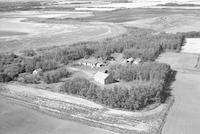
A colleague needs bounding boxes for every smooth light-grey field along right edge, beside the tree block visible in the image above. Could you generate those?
[158,53,200,134]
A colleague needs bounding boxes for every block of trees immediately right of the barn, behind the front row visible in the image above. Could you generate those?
[109,62,171,81]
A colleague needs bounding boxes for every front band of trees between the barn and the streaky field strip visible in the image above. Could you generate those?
[61,78,168,110]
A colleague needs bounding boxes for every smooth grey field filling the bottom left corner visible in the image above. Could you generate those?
[0,97,114,134]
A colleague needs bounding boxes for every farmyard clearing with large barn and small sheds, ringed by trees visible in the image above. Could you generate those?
[76,54,142,85]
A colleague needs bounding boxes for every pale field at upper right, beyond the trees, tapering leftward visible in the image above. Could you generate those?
[123,11,200,33]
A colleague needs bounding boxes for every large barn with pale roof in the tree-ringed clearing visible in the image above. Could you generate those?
[94,72,114,85]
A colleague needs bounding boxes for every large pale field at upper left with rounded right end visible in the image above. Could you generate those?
[0,11,126,52]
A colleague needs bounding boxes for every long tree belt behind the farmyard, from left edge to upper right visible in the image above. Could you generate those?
[0,28,185,82]
